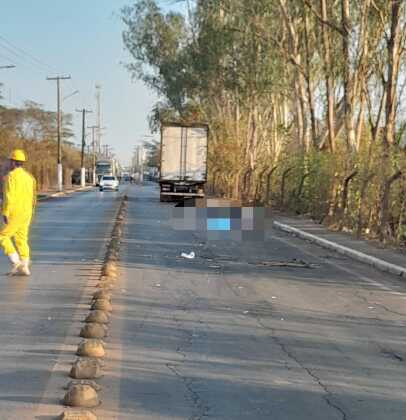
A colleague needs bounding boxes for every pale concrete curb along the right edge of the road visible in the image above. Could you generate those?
[273,222,406,278]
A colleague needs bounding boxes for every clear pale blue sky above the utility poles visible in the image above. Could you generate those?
[0,0,182,164]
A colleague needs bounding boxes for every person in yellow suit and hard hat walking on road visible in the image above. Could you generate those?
[0,149,37,276]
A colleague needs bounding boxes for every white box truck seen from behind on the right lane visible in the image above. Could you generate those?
[159,122,209,201]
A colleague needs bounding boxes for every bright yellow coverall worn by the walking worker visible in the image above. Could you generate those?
[0,168,37,260]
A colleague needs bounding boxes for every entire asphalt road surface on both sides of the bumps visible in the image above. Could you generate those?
[0,186,406,420]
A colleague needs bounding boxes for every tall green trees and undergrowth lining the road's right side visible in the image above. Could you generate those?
[122,0,406,246]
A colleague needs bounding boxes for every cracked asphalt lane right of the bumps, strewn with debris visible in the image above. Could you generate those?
[97,186,406,420]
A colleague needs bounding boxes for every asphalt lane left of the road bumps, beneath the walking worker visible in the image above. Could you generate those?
[0,191,121,420]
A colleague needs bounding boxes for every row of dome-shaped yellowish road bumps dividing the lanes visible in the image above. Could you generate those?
[60,196,128,420]
